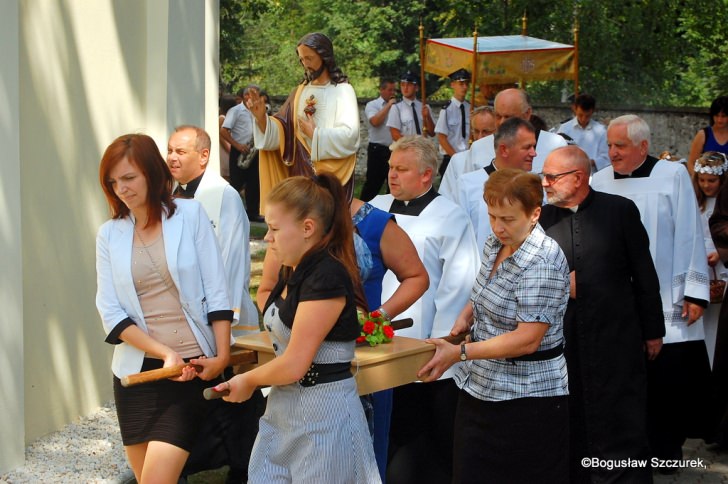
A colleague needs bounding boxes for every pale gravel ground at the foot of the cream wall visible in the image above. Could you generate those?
[0,402,133,484]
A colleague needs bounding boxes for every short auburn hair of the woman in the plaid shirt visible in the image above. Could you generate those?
[483,168,543,214]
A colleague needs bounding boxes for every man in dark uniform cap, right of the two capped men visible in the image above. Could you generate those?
[435,69,470,175]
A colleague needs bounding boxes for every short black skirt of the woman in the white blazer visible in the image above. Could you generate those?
[114,358,217,452]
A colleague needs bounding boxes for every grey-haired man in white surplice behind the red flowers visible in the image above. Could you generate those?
[369,136,480,482]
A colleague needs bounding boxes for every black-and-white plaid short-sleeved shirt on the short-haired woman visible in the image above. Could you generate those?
[454,225,569,401]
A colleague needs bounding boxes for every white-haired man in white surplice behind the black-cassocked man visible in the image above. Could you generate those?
[592,115,710,466]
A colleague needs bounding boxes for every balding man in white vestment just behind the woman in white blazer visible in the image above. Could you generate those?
[167,125,265,482]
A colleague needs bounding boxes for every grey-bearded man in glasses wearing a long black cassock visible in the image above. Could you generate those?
[540,146,665,482]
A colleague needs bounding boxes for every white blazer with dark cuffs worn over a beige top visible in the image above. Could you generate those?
[96,199,232,378]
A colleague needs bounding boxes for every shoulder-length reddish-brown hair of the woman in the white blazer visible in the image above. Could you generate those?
[99,134,177,224]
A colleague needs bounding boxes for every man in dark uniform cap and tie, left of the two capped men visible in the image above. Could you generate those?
[387,71,435,141]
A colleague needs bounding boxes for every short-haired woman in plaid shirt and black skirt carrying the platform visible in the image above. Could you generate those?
[419,169,569,483]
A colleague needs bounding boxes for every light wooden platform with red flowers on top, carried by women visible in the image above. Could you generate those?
[235,332,435,395]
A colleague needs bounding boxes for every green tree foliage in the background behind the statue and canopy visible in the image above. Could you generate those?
[220,0,728,106]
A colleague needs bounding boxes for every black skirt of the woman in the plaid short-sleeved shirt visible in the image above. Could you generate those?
[452,391,569,484]
